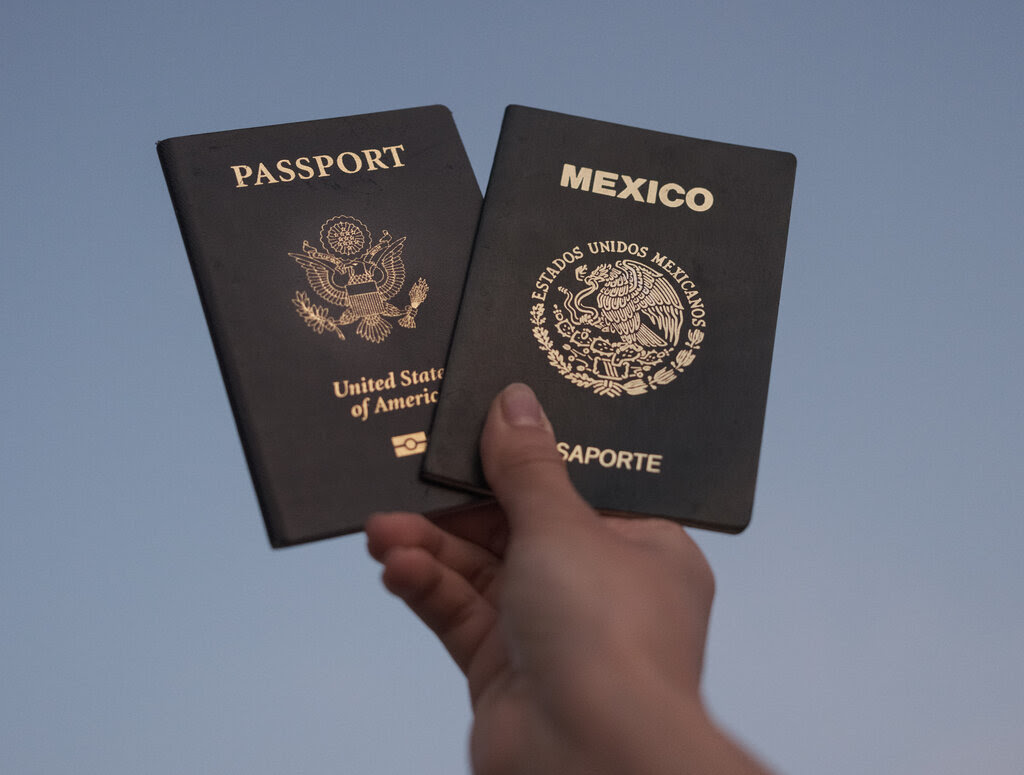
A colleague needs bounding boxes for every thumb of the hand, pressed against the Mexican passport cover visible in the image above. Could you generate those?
[480,383,594,532]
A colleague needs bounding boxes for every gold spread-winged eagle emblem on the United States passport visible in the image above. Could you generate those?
[288,215,430,344]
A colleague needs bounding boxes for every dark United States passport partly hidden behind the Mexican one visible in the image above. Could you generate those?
[157,105,480,547]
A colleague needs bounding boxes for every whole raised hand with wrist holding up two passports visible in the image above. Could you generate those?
[367,385,764,775]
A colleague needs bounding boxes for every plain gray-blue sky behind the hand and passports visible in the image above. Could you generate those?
[0,2,1024,775]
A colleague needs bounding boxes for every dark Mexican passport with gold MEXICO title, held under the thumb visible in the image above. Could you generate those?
[424,105,796,532]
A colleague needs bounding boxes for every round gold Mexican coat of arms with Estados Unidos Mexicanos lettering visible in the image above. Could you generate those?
[529,241,708,397]
